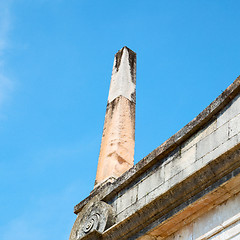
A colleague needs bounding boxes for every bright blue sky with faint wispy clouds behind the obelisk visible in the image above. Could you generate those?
[0,0,240,240]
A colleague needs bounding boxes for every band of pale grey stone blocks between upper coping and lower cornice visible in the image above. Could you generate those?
[111,95,240,223]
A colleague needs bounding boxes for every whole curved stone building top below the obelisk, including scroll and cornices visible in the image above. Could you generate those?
[70,77,240,240]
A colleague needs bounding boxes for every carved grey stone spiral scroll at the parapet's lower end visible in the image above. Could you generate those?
[69,201,115,240]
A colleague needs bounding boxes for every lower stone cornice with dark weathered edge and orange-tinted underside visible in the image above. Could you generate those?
[102,144,240,240]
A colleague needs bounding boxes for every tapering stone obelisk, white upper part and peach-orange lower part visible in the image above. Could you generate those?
[95,47,136,185]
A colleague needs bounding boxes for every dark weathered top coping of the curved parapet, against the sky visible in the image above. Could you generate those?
[74,77,240,214]
